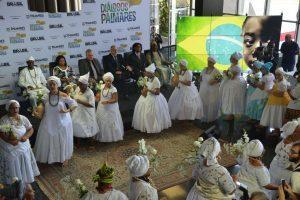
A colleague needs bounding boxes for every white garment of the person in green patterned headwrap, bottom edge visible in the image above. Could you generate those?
[81,189,128,200]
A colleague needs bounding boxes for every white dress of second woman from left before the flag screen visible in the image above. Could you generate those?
[199,68,220,122]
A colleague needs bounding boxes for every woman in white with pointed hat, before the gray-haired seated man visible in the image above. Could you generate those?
[71,73,99,138]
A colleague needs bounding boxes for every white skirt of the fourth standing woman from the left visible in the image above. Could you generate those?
[95,102,124,142]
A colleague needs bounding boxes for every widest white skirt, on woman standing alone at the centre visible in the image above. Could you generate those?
[132,93,172,133]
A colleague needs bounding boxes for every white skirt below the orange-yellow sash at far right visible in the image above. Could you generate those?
[260,104,286,128]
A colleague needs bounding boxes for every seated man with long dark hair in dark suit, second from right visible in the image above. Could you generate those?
[126,43,146,80]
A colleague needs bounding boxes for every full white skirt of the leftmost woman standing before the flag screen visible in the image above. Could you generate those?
[168,84,203,120]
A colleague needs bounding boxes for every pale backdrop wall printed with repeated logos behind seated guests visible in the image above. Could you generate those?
[0,0,150,104]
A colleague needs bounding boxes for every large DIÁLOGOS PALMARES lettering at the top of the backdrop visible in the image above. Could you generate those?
[100,0,141,24]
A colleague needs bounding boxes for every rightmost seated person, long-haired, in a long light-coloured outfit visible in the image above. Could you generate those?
[146,41,172,85]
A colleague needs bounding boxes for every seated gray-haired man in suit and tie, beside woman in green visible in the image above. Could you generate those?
[78,49,104,81]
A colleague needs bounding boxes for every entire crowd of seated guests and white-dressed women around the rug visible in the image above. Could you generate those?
[0,34,300,200]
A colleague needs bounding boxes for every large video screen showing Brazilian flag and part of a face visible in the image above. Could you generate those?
[176,16,282,72]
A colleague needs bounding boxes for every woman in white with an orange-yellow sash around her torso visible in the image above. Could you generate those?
[260,67,291,133]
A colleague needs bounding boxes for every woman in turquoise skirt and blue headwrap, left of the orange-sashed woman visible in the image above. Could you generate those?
[246,62,275,121]
